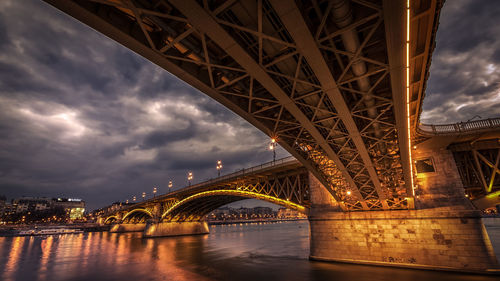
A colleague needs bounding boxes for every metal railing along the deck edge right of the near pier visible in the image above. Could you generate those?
[417,117,500,135]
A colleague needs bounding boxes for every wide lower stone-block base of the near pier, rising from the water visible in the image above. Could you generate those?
[309,208,498,271]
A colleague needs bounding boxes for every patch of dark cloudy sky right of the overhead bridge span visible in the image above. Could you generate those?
[421,0,500,123]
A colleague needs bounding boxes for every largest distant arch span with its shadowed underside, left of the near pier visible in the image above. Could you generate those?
[161,190,307,221]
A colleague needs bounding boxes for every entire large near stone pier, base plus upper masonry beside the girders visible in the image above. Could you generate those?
[309,145,500,273]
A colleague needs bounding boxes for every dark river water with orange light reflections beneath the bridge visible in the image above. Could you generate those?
[0,221,498,281]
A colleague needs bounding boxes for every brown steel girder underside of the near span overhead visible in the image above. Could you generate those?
[46,0,442,210]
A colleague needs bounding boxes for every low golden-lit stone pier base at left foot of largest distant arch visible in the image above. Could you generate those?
[143,222,210,237]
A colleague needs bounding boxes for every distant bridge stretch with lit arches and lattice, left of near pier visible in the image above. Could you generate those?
[103,157,310,224]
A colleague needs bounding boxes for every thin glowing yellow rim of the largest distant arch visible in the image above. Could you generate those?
[161,190,306,220]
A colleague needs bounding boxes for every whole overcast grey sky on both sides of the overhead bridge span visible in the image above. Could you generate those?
[0,0,500,209]
